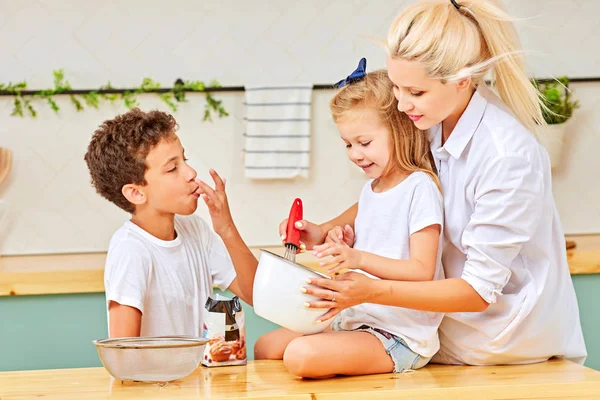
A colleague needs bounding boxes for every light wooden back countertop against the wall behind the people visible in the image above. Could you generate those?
[0,235,600,296]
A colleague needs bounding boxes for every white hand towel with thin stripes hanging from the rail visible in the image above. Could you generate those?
[244,85,312,179]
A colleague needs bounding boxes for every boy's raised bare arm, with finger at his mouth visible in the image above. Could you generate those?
[196,169,258,305]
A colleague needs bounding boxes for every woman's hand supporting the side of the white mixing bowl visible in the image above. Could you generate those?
[300,272,378,322]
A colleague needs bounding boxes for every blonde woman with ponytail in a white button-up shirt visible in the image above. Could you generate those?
[290,0,586,365]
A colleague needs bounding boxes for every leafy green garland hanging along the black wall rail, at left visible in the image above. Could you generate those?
[0,69,229,122]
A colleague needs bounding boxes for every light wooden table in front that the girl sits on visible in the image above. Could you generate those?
[0,360,600,400]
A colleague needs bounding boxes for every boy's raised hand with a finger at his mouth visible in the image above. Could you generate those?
[196,169,235,237]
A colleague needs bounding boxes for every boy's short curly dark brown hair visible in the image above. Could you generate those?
[84,108,177,213]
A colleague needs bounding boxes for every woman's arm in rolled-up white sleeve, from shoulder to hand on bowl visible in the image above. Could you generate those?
[307,154,544,317]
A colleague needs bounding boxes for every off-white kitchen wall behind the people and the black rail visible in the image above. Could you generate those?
[0,0,600,254]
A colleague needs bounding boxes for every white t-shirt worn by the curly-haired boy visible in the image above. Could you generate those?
[104,214,236,336]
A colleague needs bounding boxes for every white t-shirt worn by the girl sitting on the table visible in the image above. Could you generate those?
[341,172,444,357]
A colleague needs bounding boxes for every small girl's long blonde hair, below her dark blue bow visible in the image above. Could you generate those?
[329,70,441,191]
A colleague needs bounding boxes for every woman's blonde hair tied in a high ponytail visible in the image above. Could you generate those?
[387,0,545,133]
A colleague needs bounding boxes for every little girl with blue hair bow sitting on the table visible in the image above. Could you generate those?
[257,59,443,378]
